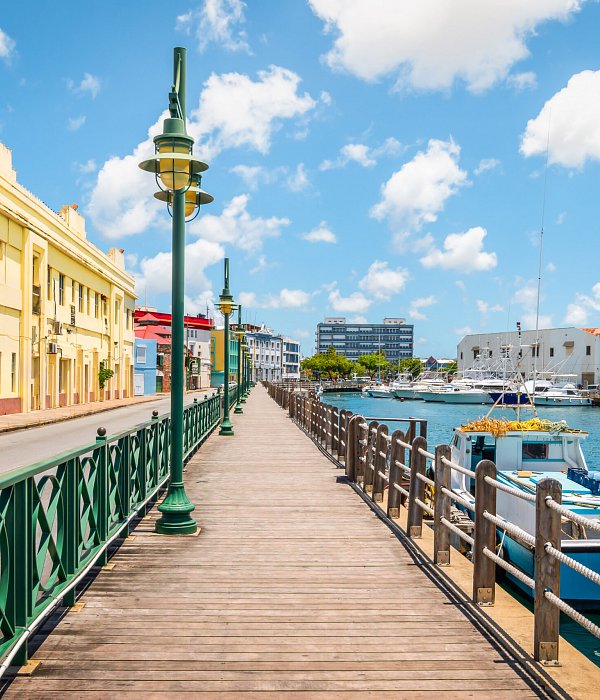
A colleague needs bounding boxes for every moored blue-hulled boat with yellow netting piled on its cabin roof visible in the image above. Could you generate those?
[451,418,600,608]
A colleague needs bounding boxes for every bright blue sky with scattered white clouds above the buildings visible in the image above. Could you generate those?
[0,0,600,356]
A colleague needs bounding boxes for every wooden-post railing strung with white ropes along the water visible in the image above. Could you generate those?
[267,383,600,664]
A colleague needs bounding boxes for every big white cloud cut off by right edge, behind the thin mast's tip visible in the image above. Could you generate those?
[521,70,600,168]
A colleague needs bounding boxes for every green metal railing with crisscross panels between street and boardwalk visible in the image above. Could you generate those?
[0,396,223,675]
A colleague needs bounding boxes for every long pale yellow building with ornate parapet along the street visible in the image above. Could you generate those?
[0,143,135,414]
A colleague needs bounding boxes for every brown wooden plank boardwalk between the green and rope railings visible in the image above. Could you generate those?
[6,387,554,700]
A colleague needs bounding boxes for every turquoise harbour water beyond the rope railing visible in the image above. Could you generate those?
[322,393,600,666]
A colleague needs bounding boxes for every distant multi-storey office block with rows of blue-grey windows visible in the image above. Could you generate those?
[316,316,414,362]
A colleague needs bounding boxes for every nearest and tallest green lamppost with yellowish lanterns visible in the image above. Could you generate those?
[139,47,213,535]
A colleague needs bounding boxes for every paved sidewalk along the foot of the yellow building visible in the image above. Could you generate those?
[0,388,214,433]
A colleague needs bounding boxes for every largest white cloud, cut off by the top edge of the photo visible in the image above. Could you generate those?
[309,0,584,92]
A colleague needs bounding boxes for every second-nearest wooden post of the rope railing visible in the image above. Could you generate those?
[473,459,496,605]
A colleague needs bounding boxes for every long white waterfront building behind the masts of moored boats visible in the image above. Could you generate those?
[457,327,600,387]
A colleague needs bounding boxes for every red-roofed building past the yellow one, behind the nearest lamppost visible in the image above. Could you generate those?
[135,306,213,392]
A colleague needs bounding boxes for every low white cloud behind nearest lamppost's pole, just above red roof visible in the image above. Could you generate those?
[133,239,225,299]
